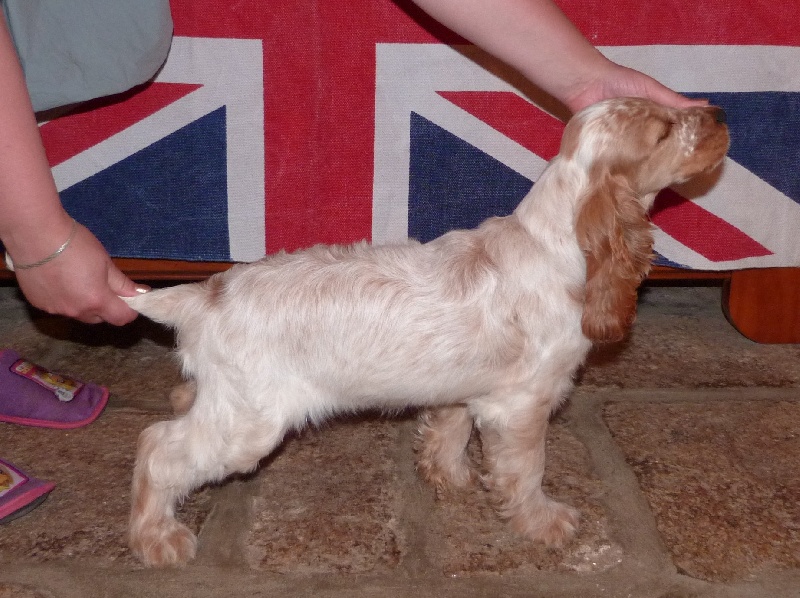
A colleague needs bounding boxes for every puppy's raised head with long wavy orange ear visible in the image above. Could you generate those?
[560,98,730,341]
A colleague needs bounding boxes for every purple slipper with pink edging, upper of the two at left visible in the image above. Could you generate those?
[0,349,108,429]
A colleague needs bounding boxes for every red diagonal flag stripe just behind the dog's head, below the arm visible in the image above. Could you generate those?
[438,91,564,160]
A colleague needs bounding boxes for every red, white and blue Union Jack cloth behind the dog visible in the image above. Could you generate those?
[41,0,800,270]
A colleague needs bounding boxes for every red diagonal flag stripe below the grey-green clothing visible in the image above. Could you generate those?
[39,83,202,166]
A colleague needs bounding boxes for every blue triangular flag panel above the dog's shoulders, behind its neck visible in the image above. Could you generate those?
[408,112,533,242]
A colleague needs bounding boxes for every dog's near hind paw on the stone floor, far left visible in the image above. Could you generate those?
[130,519,197,567]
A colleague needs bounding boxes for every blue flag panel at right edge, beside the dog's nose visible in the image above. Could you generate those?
[686,91,800,203]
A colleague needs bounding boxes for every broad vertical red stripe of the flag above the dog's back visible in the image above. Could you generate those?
[258,2,450,253]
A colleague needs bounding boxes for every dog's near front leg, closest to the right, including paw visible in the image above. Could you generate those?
[480,401,578,546]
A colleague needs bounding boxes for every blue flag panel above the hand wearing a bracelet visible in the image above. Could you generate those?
[61,107,230,261]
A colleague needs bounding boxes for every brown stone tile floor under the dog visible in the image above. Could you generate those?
[0,286,800,598]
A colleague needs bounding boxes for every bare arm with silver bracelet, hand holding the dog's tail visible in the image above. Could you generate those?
[0,12,144,325]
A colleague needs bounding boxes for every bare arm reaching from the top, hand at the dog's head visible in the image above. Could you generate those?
[414,0,702,112]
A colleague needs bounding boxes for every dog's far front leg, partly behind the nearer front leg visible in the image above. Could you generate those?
[416,405,474,495]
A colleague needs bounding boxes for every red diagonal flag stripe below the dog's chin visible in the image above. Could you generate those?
[651,189,772,262]
